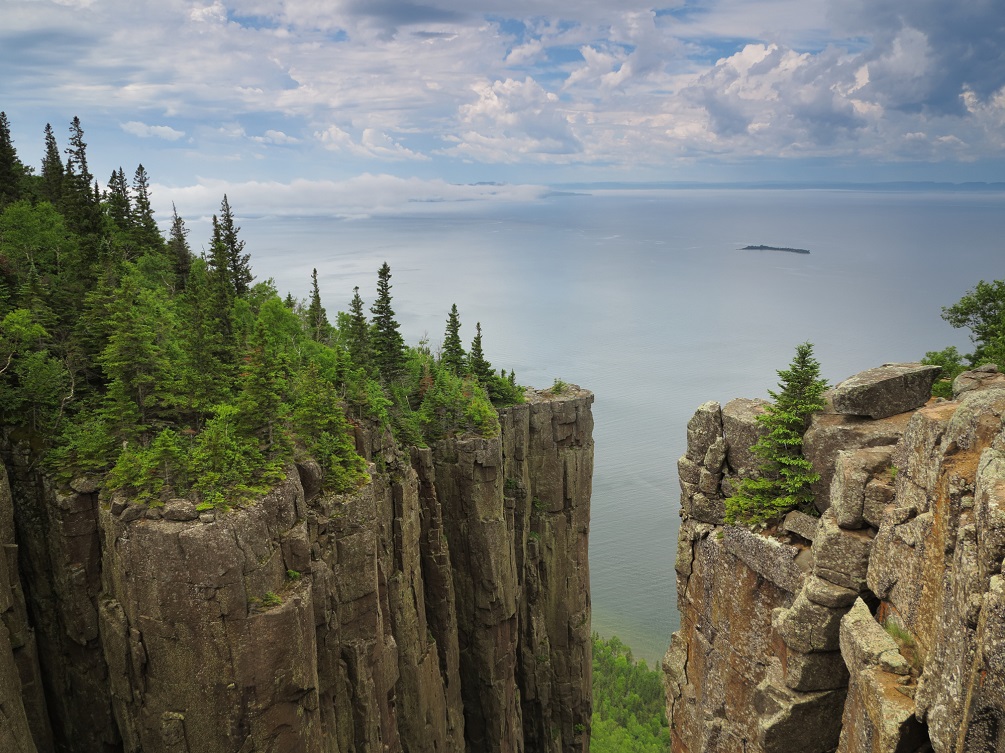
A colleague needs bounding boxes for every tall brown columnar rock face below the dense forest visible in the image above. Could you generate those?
[0,388,593,753]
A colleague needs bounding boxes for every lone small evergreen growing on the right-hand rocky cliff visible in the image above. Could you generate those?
[726,343,827,526]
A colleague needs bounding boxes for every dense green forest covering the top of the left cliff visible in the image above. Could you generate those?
[0,114,522,506]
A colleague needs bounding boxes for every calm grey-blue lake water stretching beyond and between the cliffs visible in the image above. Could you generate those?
[228,190,1005,664]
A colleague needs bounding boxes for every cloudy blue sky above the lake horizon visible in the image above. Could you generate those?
[0,0,1005,215]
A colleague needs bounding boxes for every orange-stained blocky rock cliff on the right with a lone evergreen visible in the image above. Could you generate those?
[663,364,1005,753]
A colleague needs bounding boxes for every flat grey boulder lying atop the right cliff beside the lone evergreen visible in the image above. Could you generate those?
[831,363,942,418]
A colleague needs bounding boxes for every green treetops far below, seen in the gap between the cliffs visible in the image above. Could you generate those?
[590,633,670,753]
